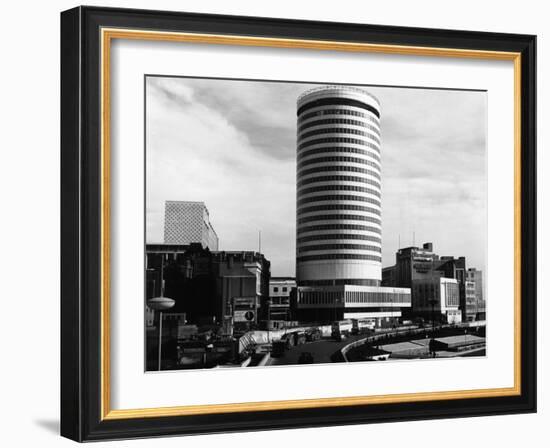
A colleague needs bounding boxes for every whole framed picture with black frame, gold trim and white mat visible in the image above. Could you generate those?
[61,7,536,441]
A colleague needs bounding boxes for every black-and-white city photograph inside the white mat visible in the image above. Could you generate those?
[145,76,488,371]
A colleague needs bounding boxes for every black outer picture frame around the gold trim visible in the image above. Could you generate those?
[61,7,537,441]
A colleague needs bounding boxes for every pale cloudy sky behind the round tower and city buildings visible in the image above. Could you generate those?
[146,77,487,276]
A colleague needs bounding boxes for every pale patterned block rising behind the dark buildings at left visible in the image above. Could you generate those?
[164,201,218,251]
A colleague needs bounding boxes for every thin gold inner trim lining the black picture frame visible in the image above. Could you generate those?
[100,28,521,420]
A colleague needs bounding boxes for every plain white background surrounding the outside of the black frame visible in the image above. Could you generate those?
[0,0,550,448]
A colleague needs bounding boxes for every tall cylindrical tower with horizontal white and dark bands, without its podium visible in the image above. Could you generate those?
[296,86,382,286]
